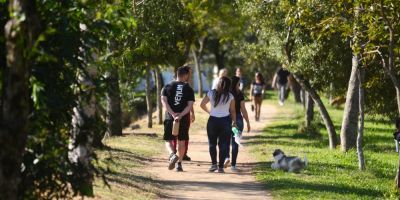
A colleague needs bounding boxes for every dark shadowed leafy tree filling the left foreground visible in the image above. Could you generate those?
[0,0,139,199]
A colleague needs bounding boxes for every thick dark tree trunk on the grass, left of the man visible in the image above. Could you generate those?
[106,65,122,136]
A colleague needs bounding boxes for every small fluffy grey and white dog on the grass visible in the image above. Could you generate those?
[271,149,308,173]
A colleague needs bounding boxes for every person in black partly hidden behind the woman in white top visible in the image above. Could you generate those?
[224,76,250,171]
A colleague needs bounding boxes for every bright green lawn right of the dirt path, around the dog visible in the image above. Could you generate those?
[251,92,398,199]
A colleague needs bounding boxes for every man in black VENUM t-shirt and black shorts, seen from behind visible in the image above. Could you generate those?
[161,66,194,171]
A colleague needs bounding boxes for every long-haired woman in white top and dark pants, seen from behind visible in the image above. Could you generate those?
[200,77,236,173]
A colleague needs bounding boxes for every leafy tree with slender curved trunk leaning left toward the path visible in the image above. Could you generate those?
[238,1,354,148]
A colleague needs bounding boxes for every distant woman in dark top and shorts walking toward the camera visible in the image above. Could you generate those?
[250,72,265,121]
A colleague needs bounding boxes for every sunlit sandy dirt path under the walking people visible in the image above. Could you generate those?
[148,102,276,199]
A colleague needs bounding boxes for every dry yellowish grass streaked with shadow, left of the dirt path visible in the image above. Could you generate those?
[94,135,162,200]
